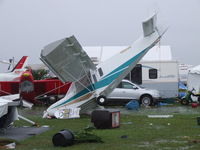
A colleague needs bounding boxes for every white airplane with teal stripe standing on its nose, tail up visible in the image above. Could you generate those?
[41,14,167,118]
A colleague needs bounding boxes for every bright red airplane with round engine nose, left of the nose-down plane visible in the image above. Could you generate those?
[0,71,71,104]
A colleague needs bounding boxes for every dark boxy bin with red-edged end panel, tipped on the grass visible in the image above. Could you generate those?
[91,109,120,129]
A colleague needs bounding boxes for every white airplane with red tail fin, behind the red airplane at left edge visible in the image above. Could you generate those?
[0,56,28,81]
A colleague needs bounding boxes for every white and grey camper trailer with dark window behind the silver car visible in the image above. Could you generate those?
[126,60,178,98]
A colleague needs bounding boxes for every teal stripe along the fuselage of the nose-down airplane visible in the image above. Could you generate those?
[53,44,155,108]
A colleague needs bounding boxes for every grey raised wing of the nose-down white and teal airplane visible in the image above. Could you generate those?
[41,36,96,82]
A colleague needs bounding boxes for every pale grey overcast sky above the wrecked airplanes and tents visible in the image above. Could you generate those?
[0,0,200,71]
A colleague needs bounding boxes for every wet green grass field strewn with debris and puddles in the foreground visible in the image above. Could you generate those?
[1,106,200,150]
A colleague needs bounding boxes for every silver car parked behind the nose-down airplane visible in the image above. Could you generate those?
[97,80,160,106]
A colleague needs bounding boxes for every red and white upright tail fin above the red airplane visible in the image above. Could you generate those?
[11,56,28,74]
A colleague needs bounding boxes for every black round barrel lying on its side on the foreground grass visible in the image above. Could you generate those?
[52,130,74,146]
